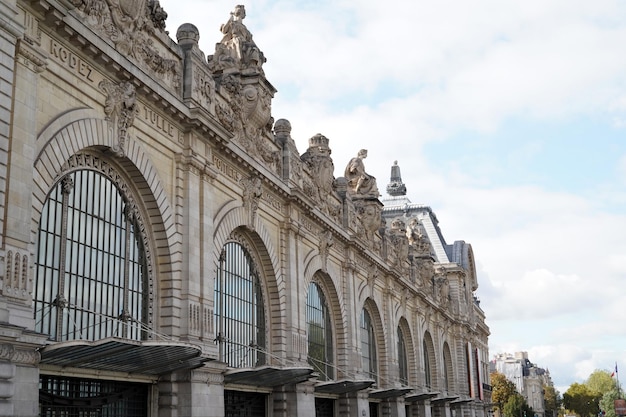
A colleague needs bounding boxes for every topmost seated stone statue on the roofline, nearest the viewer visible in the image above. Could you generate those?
[208,5,265,73]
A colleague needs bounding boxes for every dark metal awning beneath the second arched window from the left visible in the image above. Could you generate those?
[224,366,313,387]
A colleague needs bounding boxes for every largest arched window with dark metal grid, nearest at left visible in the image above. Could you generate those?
[33,169,148,341]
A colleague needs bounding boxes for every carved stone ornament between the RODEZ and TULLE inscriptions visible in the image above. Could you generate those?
[98,80,137,157]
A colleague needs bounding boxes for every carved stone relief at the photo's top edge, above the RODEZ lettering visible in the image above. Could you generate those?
[70,0,181,88]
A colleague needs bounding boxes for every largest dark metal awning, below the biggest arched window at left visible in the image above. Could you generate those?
[40,337,211,375]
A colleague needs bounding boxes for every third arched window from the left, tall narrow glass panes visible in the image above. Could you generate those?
[306,282,334,381]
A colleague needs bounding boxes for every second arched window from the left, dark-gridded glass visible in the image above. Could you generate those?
[214,242,265,368]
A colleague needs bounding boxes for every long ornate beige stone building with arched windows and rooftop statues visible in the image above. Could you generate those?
[0,0,490,417]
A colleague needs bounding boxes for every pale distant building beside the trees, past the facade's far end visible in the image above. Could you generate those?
[491,352,553,417]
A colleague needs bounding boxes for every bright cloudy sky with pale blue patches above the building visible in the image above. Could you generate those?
[161,0,626,392]
